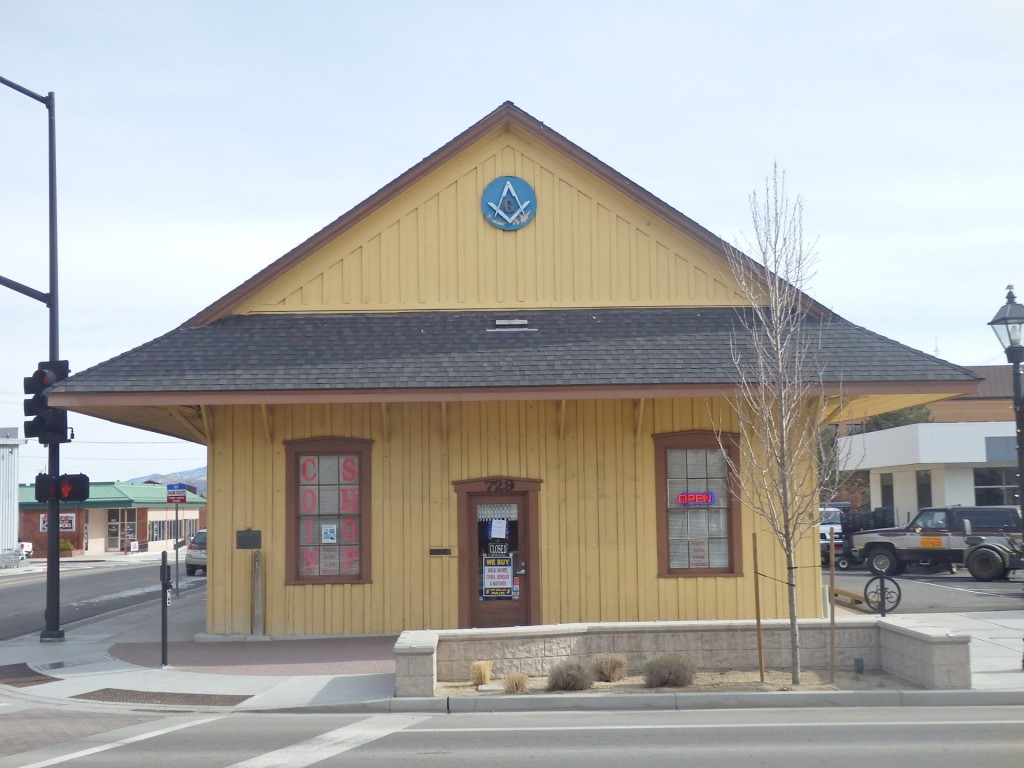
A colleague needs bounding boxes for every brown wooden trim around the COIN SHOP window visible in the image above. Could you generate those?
[285,437,374,586]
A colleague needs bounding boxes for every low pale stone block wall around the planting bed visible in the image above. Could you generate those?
[394,618,971,696]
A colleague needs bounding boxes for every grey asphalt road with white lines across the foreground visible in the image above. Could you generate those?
[0,699,1024,768]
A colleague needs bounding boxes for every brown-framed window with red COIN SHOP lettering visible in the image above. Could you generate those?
[287,439,372,584]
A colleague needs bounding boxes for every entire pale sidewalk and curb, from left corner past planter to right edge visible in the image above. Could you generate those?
[0,557,1024,712]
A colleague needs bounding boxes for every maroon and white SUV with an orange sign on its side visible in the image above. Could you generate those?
[848,506,1024,575]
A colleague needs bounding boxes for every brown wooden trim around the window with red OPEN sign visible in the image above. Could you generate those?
[654,430,743,579]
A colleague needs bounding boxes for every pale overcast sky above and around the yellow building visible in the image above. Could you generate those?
[0,0,1024,482]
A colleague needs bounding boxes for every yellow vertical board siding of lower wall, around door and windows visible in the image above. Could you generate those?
[208,398,821,636]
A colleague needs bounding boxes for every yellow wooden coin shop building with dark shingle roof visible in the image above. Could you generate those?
[50,103,976,636]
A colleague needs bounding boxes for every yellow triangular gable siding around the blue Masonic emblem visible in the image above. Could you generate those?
[237,133,742,313]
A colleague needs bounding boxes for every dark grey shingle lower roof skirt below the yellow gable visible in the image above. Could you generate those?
[58,307,976,394]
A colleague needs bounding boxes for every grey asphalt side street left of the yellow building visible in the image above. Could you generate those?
[0,560,206,640]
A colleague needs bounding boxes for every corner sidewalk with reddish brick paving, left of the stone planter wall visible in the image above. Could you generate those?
[0,593,396,710]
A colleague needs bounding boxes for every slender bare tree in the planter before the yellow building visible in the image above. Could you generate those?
[726,165,840,685]
